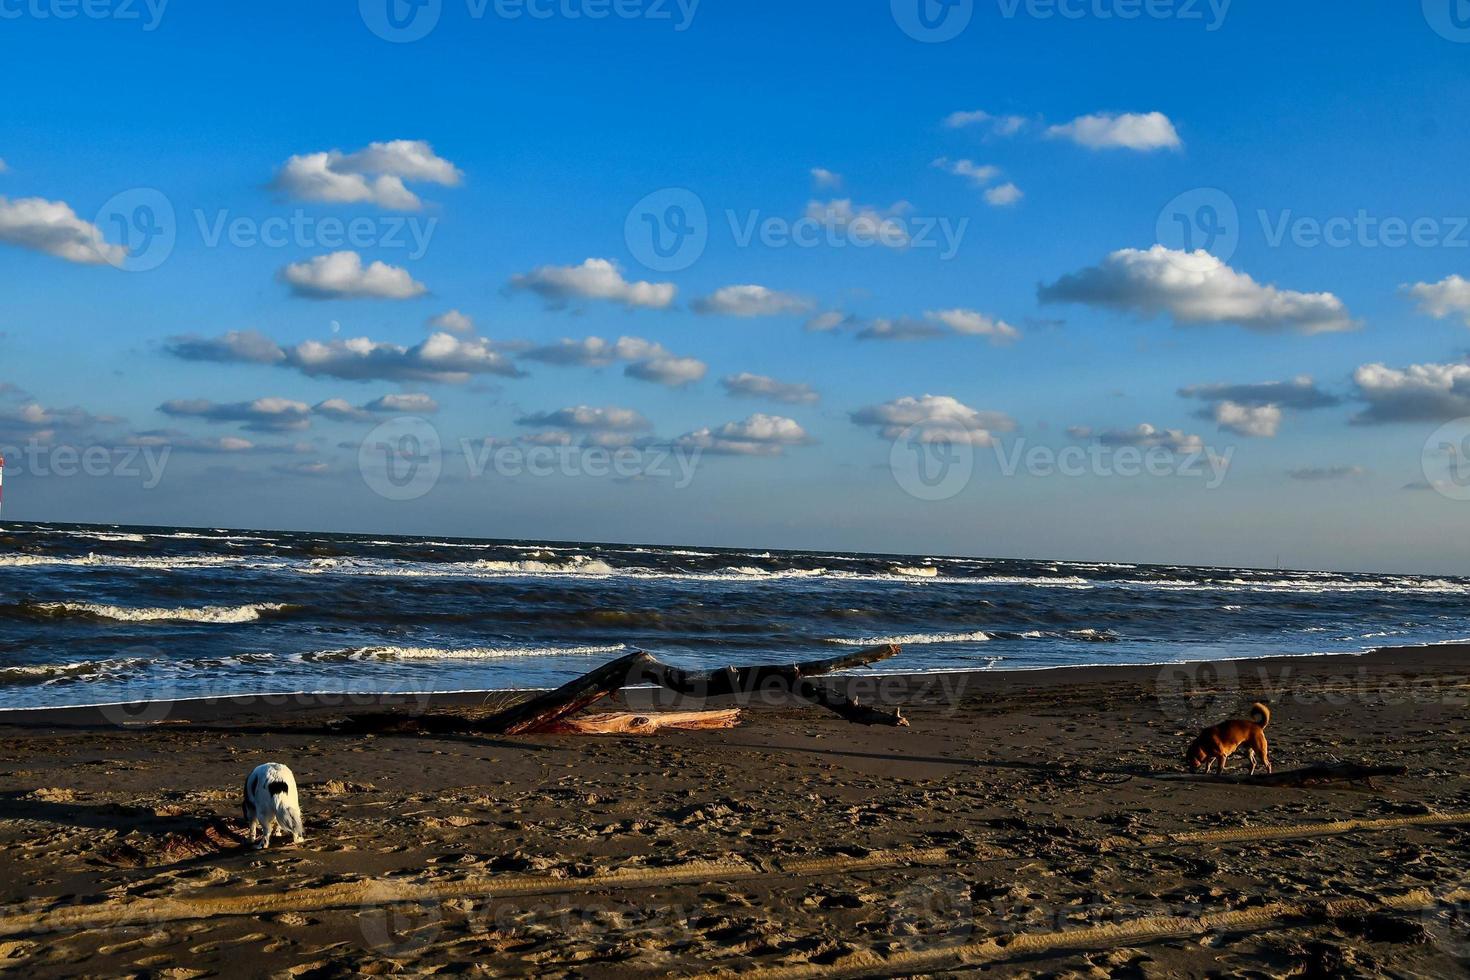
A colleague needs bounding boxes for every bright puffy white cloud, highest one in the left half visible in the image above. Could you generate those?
[273,140,462,212]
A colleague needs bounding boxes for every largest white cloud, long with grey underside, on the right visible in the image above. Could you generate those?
[1036,245,1357,334]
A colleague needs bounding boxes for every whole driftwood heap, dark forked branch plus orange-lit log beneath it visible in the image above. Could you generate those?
[348,644,908,735]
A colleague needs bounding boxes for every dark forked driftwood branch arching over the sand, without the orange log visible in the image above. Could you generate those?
[473,644,908,735]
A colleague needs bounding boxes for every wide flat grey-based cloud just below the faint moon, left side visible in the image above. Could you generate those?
[287,334,520,385]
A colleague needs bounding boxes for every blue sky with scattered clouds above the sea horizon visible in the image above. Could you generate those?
[0,0,1470,573]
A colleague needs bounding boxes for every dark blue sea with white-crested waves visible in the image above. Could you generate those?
[0,523,1470,708]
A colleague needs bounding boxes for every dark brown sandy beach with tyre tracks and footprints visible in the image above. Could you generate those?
[0,646,1470,977]
